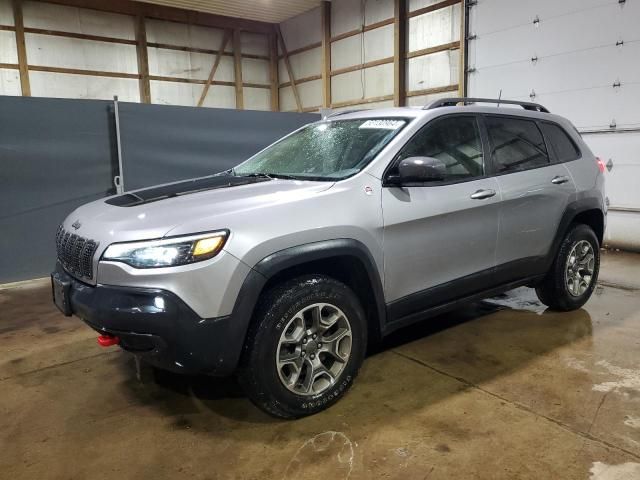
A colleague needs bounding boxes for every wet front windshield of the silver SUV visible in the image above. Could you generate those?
[233,118,408,181]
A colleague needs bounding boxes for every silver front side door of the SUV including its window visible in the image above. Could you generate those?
[382,114,500,314]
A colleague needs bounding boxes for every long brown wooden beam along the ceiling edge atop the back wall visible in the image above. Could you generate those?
[37,0,273,34]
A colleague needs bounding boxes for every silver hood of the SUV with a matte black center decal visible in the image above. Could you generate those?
[63,177,333,244]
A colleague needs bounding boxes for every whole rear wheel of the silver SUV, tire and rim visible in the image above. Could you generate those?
[536,224,600,311]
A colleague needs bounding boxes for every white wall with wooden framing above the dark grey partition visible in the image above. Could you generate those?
[0,0,463,112]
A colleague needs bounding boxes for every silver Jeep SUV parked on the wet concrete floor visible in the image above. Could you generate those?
[52,98,606,418]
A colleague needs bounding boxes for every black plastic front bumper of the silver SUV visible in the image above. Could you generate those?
[51,262,248,375]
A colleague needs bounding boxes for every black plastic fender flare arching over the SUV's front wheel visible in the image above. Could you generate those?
[222,238,386,372]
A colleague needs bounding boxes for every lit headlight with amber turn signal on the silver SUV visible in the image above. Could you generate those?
[102,230,228,268]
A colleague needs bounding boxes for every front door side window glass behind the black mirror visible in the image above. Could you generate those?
[400,116,484,181]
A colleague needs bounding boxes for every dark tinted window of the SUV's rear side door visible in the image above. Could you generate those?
[486,117,549,172]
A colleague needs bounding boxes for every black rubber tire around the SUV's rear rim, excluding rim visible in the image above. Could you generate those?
[536,224,600,311]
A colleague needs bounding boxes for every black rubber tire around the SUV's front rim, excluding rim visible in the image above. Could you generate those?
[238,275,367,419]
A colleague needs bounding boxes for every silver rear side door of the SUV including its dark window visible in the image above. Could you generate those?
[483,115,576,281]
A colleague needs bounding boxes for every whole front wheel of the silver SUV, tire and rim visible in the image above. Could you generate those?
[239,275,367,418]
